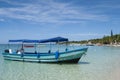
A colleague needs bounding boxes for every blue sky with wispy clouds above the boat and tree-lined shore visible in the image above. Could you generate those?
[0,0,120,43]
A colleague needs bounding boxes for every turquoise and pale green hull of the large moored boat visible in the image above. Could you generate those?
[3,48,87,63]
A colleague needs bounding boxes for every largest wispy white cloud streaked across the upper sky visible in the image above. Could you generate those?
[0,0,108,23]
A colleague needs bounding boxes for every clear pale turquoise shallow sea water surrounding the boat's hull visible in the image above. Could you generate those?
[0,45,120,80]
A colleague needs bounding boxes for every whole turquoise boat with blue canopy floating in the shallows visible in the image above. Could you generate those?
[2,37,88,63]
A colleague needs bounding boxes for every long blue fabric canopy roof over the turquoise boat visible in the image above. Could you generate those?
[9,37,68,43]
